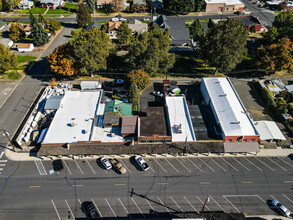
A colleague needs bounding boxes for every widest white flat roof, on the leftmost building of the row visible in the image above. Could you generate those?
[43,90,102,144]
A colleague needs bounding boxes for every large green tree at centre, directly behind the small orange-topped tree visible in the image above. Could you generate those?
[126,25,175,74]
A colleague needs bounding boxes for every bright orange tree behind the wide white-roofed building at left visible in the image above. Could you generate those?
[48,43,77,76]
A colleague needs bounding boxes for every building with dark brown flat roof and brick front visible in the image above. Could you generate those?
[138,107,172,142]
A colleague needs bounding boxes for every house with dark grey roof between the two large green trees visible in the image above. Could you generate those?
[153,15,190,46]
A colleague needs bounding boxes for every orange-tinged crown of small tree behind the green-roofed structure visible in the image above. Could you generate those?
[127,69,151,91]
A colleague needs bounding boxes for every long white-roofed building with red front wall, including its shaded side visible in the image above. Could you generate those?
[200,77,260,142]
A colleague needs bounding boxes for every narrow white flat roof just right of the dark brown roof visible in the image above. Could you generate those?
[166,96,196,142]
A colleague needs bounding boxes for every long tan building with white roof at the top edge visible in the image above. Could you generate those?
[205,0,245,13]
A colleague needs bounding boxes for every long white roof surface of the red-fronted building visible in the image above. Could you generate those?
[203,77,258,136]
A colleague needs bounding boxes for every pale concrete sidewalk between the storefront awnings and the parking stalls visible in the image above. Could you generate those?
[5,147,293,161]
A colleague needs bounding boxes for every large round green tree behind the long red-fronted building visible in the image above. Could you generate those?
[199,19,248,74]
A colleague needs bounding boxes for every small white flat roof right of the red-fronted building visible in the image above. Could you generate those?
[254,121,286,141]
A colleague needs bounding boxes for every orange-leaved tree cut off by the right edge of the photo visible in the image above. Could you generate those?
[256,38,293,71]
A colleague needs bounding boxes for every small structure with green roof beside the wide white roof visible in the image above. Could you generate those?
[104,99,132,116]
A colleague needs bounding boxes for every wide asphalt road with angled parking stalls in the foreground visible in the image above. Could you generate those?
[0,157,293,219]
